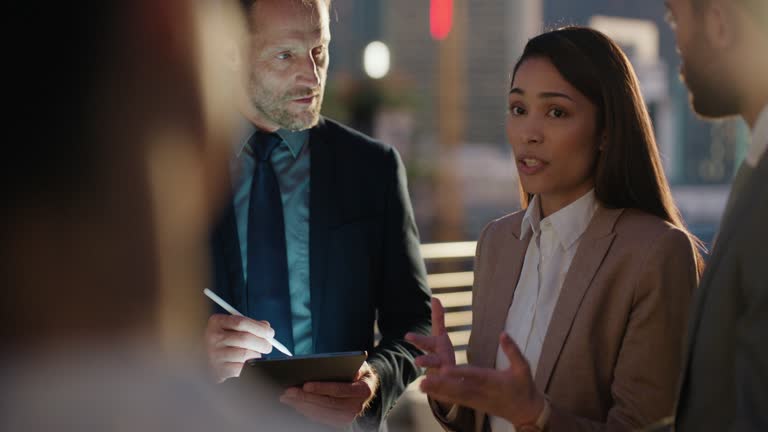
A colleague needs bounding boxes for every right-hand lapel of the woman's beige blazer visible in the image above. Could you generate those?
[534,207,623,391]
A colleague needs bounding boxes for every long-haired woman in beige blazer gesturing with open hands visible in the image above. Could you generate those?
[406,27,701,432]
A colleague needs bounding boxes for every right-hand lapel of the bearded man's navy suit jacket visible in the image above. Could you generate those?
[309,118,334,352]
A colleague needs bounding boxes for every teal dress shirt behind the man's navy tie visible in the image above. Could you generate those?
[230,122,313,355]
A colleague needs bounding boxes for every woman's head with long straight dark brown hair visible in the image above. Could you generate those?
[507,27,695,266]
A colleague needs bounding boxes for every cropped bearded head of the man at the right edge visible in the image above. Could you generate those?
[666,0,768,125]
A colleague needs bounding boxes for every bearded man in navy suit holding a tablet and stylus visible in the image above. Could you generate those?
[206,0,430,429]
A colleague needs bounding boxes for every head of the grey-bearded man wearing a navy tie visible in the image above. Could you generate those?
[233,0,331,131]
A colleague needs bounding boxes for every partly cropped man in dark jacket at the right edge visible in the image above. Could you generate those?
[666,0,768,431]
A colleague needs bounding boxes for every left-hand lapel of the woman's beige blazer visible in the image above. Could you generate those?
[473,224,531,368]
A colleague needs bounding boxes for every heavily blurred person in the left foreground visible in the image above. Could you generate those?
[0,0,306,431]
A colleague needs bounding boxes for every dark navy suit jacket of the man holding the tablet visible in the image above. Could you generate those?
[212,115,431,421]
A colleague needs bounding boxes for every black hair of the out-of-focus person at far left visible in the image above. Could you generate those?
[5,1,126,213]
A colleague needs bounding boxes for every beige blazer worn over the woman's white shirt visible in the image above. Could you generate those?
[432,208,698,432]
